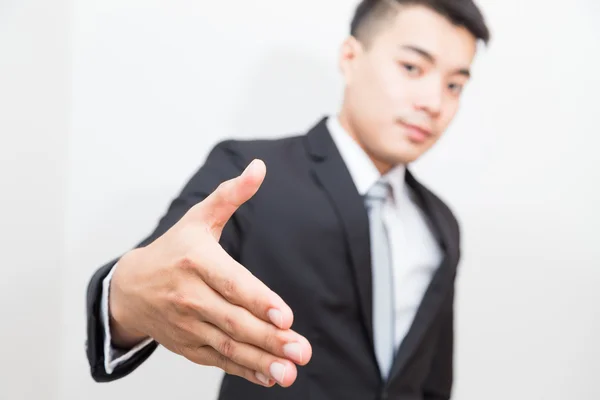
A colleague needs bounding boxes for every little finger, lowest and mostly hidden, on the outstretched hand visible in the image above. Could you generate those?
[184,346,275,387]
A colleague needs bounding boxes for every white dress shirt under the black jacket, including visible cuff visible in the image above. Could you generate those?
[101,117,442,374]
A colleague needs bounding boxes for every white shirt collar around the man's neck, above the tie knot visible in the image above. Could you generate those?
[327,116,406,203]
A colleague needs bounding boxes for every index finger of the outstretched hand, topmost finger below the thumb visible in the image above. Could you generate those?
[198,243,294,329]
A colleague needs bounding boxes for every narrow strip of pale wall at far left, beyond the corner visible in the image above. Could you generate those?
[0,0,71,400]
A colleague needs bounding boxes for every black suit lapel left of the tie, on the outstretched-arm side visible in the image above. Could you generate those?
[307,119,373,344]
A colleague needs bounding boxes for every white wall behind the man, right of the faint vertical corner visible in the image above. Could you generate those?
[62,0,600,400]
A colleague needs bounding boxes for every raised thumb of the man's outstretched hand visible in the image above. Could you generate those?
[195,160,266,240]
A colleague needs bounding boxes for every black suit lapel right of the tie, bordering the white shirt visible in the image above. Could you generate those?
[390,171,458,379]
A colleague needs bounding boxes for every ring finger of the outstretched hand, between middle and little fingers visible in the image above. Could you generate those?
[202,323,298,387]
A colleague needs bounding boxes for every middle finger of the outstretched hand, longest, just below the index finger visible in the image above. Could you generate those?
[198,280,312,365]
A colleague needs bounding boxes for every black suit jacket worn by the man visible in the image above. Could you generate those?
[87,119,459,400]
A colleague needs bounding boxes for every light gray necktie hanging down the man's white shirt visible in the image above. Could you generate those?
[365,181,395,379]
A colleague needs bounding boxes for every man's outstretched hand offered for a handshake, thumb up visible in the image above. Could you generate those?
[109,160,312,387]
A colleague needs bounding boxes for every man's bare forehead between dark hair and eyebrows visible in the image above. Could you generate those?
[380,6,477,67]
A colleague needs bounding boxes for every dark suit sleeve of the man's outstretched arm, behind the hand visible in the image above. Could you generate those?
[86,141,246,382]
